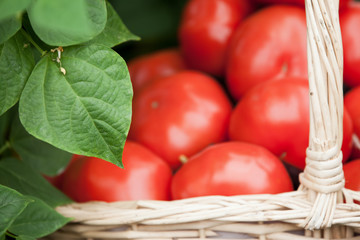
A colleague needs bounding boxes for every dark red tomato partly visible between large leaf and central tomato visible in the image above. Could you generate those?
[128,48,186,93]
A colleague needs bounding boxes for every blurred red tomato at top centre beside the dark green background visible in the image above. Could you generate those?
[179,0,252,76]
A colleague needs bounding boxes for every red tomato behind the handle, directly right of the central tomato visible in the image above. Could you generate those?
[229,78,353,169]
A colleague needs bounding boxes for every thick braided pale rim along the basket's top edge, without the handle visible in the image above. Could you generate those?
[57,189,360,228]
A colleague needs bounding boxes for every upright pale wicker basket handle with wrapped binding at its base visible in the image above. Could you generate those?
[300,0,345,230]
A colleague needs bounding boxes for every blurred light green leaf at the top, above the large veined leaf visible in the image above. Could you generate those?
[28,0,107,46]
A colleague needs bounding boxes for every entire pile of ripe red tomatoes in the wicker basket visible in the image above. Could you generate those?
[48,0,360,202]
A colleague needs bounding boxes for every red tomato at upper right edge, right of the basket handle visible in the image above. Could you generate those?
[339,2,360,87]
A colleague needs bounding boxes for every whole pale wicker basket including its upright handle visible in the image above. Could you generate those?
[48,0,360,240]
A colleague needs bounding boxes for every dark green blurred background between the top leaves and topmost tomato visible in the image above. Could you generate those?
[109,0,187,60]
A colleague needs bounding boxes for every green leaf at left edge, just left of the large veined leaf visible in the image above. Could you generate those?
[0,32,35,115]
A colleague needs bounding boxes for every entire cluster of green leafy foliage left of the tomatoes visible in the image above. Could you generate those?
[0,0,138,240]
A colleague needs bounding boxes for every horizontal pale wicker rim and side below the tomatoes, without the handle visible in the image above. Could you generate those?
[52,189,360,239]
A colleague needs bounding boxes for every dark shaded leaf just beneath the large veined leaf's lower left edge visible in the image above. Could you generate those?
[10,112,72,176]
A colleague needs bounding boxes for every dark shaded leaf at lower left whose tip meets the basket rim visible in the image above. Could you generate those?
[0,158,71,207]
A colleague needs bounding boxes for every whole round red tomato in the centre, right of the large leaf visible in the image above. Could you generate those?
[129,71,232,169]
